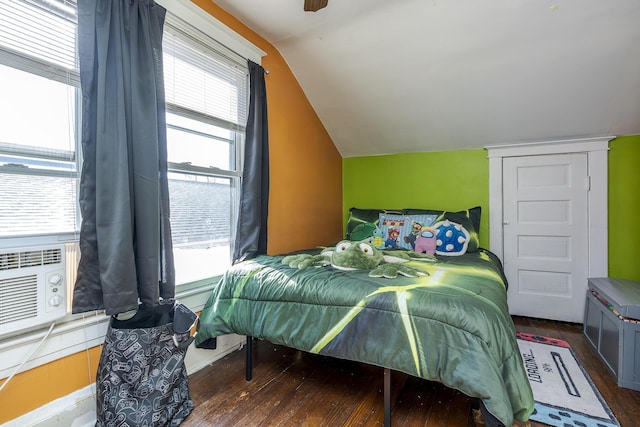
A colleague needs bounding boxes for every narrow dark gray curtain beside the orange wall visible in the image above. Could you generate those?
[233,61,269,264]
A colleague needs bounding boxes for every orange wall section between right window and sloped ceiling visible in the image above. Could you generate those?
[192,0,342,254]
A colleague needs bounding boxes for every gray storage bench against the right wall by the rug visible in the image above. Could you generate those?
[583,277,640,390]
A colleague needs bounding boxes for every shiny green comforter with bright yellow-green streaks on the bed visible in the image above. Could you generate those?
[196,249,534,426]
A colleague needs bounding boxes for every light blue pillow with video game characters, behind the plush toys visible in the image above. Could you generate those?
[378,213,437,251]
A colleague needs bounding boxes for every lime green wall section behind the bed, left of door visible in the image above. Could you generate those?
[342,150,489,248]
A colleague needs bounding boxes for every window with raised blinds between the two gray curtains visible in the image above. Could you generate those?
[163,14,248,284]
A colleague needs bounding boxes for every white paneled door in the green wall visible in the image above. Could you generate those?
[502,153,589,323]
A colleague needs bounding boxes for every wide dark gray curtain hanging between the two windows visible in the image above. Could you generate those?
[73,0,175,314]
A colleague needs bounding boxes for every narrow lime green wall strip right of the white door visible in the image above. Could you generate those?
[609,135,640,281]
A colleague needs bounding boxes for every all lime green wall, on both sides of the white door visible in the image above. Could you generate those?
[342,135,640,281]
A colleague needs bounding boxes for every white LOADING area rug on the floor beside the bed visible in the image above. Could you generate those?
[517,332,620,427]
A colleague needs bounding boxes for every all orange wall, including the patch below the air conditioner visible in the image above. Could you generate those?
[0,0,342,423]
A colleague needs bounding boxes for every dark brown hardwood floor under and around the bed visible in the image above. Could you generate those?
[182,317,640,427]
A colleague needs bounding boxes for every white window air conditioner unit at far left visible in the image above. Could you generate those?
[0,244,67,337]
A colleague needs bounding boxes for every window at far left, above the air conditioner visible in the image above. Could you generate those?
[0,0,80,241]
